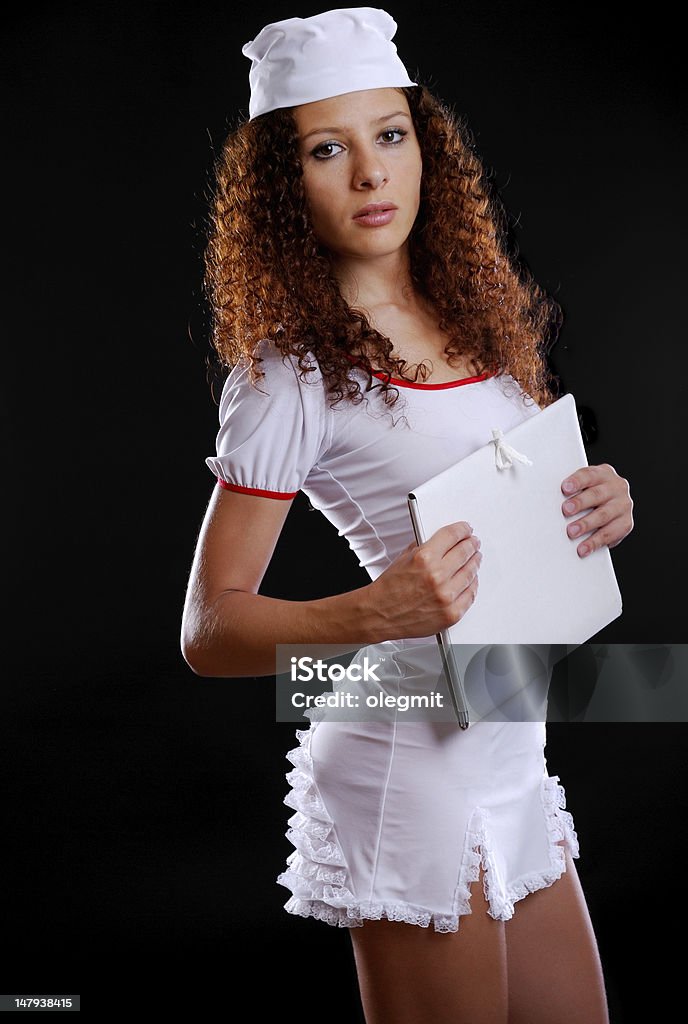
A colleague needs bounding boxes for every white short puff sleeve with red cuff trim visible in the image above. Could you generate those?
[206,341,331,499]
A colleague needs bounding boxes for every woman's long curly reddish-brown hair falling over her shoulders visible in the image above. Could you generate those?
[204,82,563,408]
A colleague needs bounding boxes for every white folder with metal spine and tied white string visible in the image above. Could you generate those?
[407,393,621,728]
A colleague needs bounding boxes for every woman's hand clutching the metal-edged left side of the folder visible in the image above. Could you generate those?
[368,520,482,640]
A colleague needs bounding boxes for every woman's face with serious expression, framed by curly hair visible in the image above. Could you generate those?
[293,88,423,258]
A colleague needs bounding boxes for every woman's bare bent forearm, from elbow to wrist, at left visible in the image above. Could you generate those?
[182,586,385,677]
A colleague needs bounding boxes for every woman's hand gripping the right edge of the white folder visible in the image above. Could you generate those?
[561,463,634,557]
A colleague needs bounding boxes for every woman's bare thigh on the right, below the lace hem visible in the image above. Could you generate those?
[505,848,609,1024]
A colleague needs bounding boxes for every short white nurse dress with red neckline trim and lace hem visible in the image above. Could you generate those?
[206,341,578,932]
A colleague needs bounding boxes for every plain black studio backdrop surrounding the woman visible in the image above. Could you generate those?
[0,0,688,1024]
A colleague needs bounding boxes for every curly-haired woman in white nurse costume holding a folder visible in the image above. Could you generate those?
[181,8,633,1024]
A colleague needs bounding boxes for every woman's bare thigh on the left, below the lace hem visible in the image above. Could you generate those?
[349,868,507,1024]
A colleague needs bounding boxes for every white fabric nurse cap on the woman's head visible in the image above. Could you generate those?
[242,7,418,121]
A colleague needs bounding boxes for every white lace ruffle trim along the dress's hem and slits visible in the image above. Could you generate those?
[276,729,579,932]
